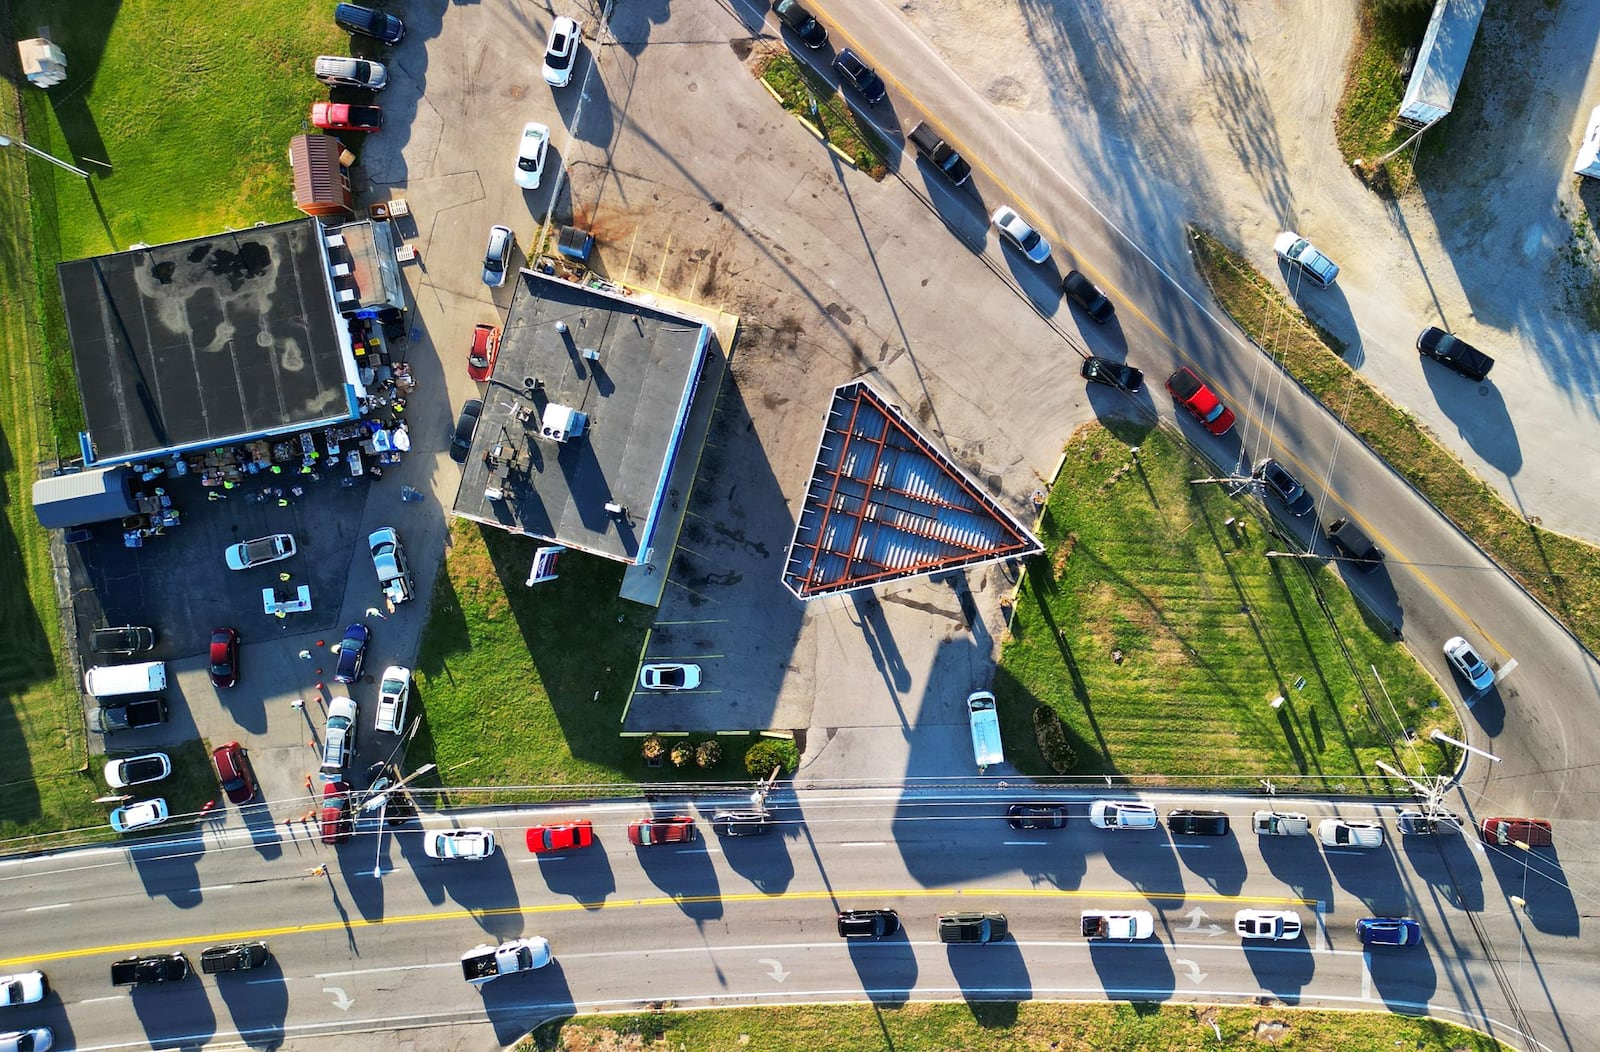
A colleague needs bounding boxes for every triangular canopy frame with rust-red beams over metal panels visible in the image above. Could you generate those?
[784,381,1043,600]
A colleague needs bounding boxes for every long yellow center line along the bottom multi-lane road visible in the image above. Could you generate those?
[0,887,1317,970]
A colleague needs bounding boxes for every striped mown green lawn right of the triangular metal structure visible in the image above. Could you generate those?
[995,424,1459,777]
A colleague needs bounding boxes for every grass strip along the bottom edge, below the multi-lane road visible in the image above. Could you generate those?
[517,1001,1507,1052]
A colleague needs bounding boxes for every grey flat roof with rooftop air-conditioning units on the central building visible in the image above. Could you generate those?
[453,270,710,563]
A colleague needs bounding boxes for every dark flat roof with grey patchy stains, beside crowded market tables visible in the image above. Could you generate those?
[56,219,355,462]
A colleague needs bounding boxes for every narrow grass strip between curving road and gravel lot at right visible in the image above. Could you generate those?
[1190,227,1600,652]
